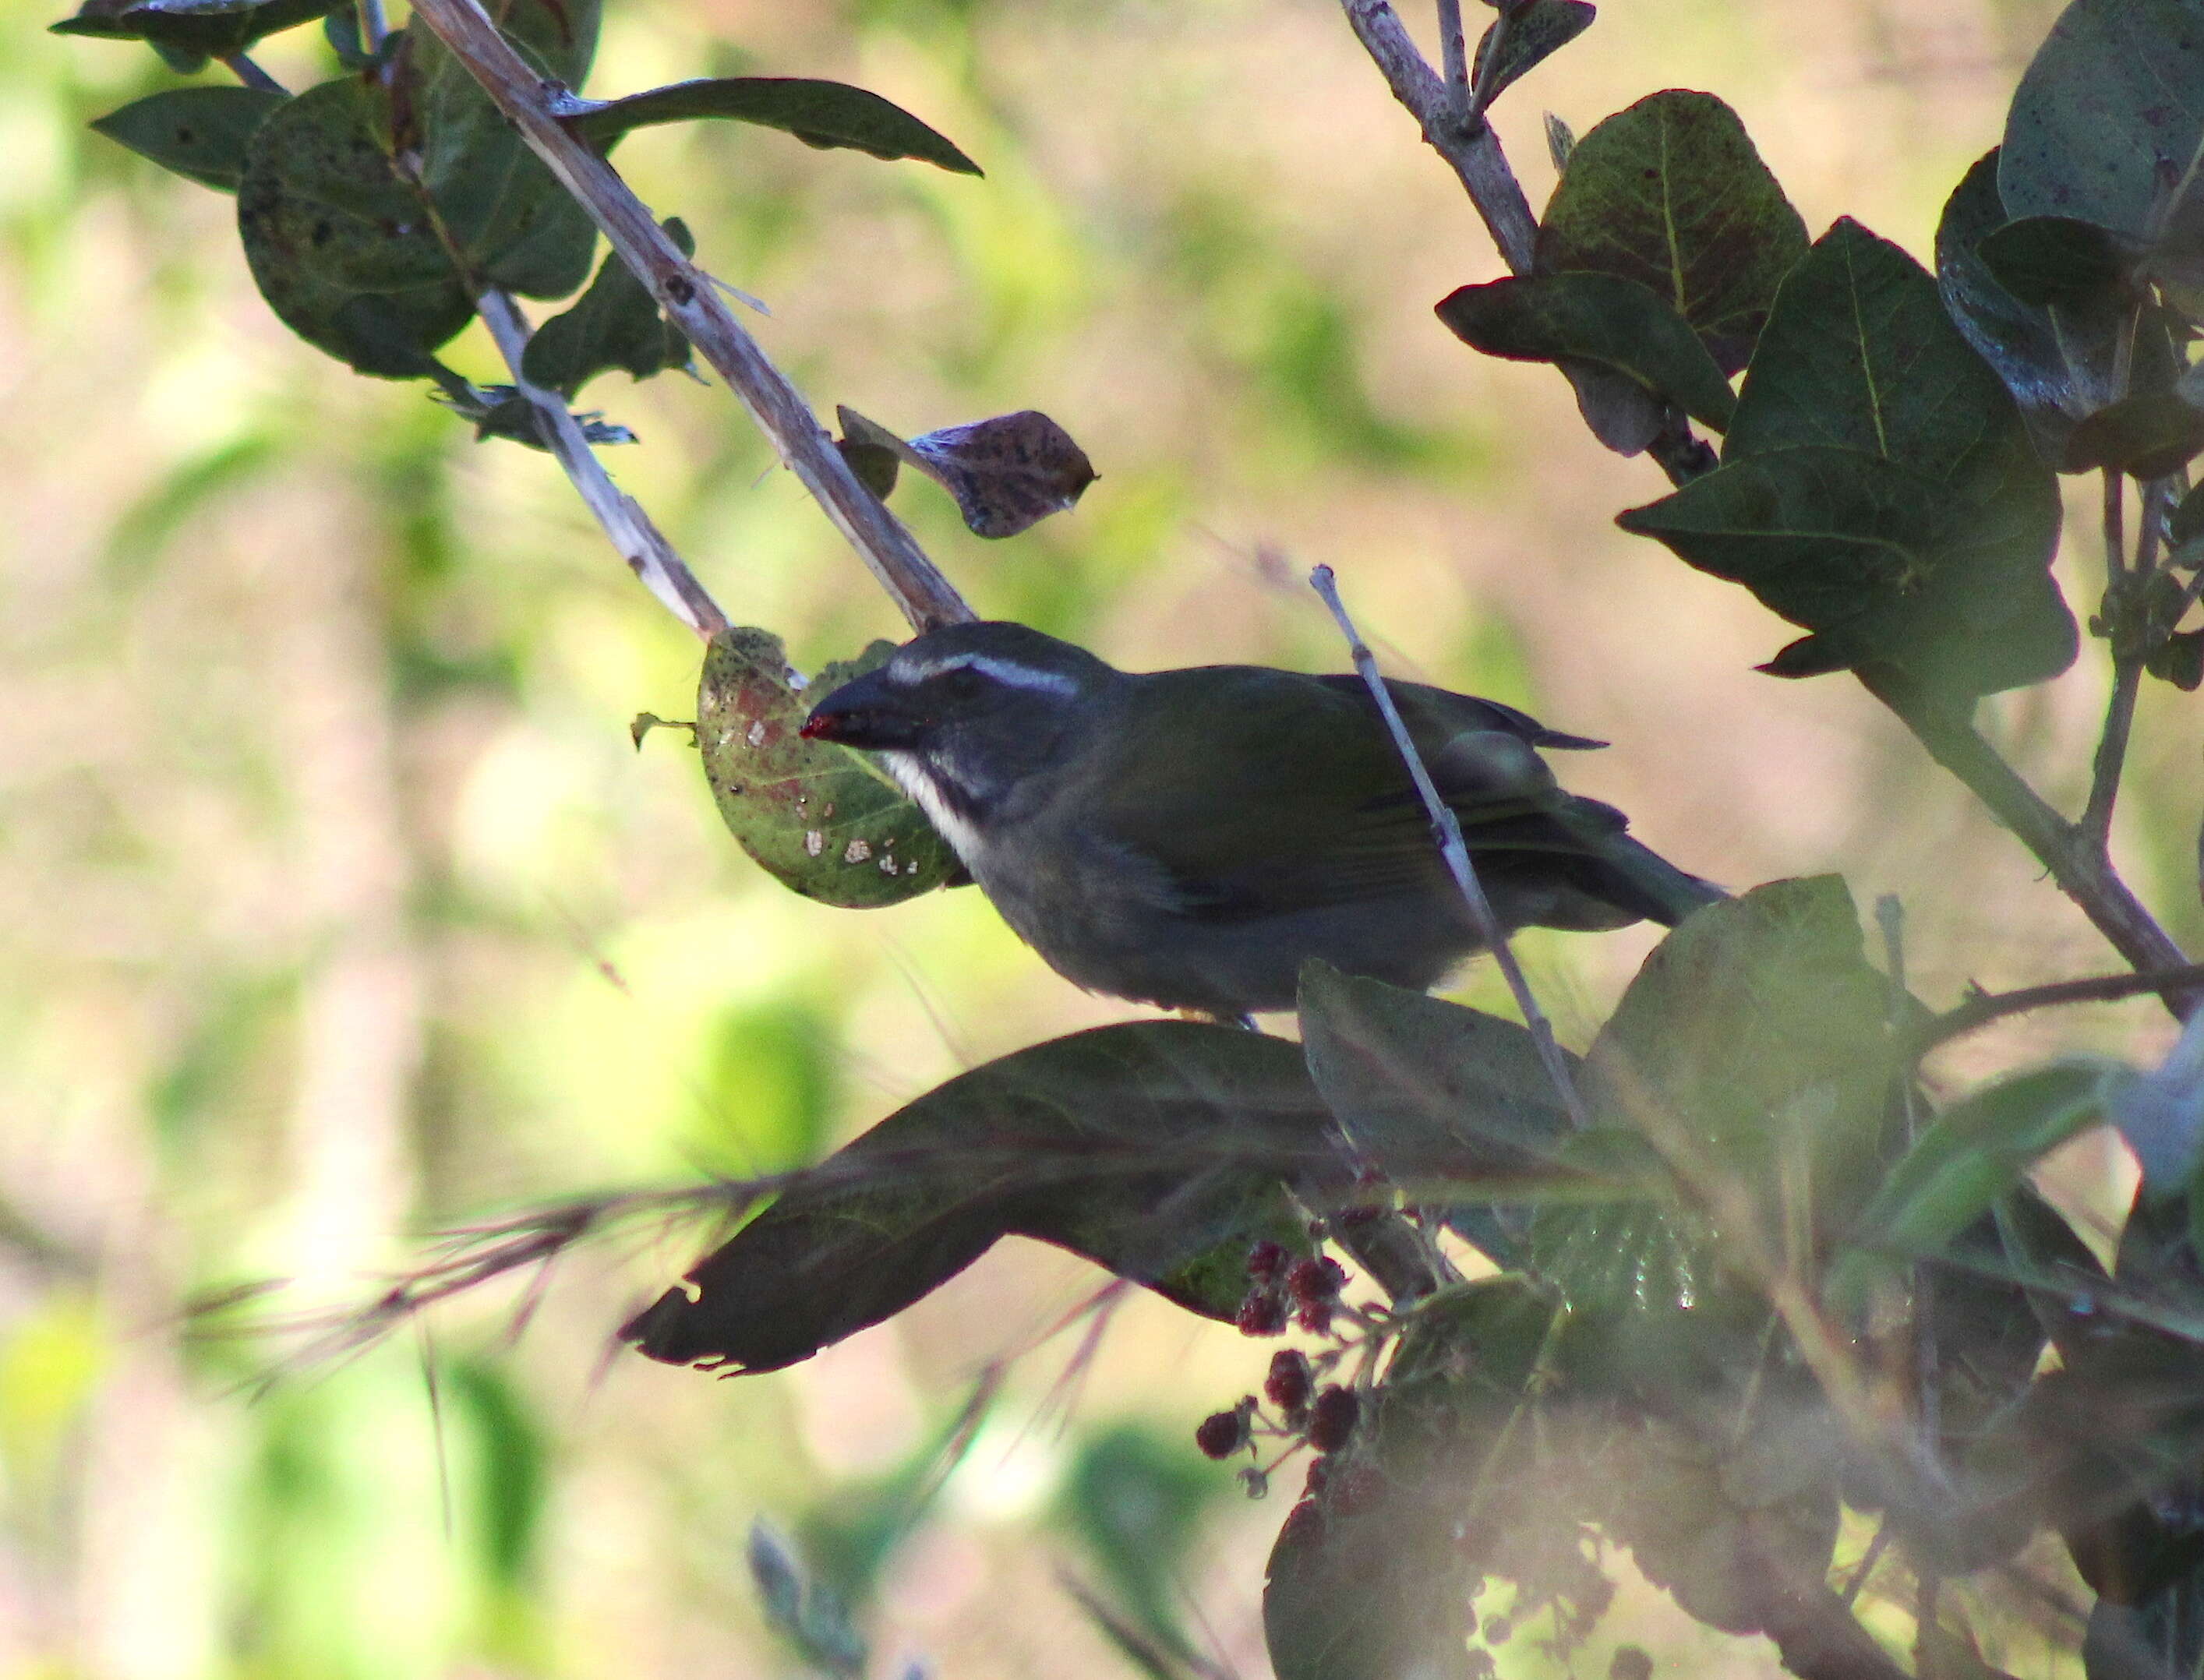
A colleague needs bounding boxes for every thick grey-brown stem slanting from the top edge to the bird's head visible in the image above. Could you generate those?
[412,0,977,630]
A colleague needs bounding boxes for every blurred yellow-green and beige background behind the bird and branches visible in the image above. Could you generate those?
[0,0,2204,1680]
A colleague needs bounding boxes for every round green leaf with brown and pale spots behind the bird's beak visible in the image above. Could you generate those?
[697,628,956,911]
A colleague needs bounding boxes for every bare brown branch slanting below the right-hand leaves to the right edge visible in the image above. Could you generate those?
[1858,665,2204,1021]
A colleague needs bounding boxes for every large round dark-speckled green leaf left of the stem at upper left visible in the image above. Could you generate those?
[238,77,474,379]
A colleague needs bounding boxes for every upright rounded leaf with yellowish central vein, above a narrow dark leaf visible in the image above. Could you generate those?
[1536,88,1807,372]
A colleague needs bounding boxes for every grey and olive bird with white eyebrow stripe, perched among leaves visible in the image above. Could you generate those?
[802,624,1722,1018]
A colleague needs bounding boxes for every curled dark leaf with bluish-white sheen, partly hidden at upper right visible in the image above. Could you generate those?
[1935,150,2127,454]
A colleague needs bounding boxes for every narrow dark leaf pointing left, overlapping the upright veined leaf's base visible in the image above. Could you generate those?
[1439,274,1736,432]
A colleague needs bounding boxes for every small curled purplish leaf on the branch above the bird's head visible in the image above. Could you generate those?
[838,408,1096,538]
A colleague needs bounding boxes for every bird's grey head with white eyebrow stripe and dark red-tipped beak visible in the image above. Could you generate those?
[802,622,1121,809]
